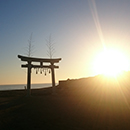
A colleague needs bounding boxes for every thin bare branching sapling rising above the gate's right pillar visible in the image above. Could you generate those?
[46,35,55,59]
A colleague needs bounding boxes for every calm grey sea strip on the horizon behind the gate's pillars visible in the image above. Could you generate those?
[0,83,52,91]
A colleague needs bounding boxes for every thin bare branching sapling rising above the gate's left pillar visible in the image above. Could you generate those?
[26,33,34,57]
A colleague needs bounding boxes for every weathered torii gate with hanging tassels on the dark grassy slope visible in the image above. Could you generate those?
[18,55,61,96]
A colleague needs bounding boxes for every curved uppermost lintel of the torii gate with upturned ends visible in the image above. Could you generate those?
[18,55,61,63]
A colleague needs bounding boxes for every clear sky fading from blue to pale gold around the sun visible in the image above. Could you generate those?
[0,0,130,85]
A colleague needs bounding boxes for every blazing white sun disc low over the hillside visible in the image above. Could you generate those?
[94,49,129,76]
